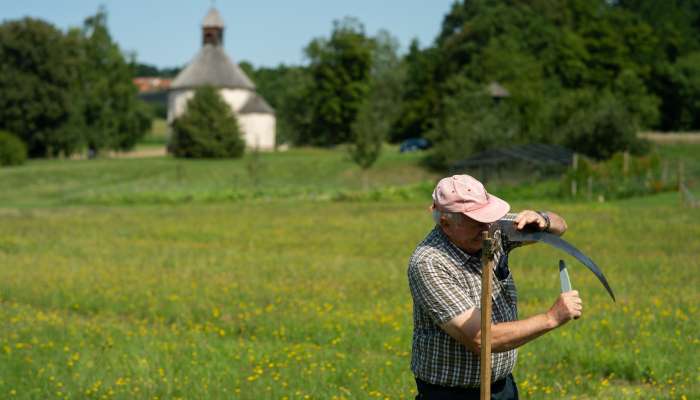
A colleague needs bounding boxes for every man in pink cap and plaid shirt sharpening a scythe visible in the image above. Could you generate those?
[408,175,582,400]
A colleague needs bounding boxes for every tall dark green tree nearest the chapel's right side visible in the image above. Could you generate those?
[299,18,372,146]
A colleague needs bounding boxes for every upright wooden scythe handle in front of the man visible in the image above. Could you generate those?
[480,232,493,400]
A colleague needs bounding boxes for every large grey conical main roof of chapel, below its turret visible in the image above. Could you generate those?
[170,44,255,90]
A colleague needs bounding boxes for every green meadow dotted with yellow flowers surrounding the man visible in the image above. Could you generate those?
[0,146,700,399]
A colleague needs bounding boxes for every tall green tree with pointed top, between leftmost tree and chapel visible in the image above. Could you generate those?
[80,8,151,153]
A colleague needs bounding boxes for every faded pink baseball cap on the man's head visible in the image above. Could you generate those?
[432,175,510,223]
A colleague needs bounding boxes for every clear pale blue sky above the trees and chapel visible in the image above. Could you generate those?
[0,0,454,68]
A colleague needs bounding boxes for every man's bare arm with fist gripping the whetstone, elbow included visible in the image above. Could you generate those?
[440,290,583,354]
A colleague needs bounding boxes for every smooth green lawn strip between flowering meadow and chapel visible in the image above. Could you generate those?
[0,147,437,207]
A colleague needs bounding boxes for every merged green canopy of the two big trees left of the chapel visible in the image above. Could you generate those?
[0,9,151,157]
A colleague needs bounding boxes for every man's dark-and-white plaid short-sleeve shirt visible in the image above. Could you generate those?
[408,222,518,387]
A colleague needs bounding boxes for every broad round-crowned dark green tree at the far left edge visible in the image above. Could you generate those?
[0,18,82,157]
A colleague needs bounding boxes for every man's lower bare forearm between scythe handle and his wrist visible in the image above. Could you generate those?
[486,313,558,353]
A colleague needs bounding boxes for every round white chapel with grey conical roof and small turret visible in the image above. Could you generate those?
[168,8,276,150]
